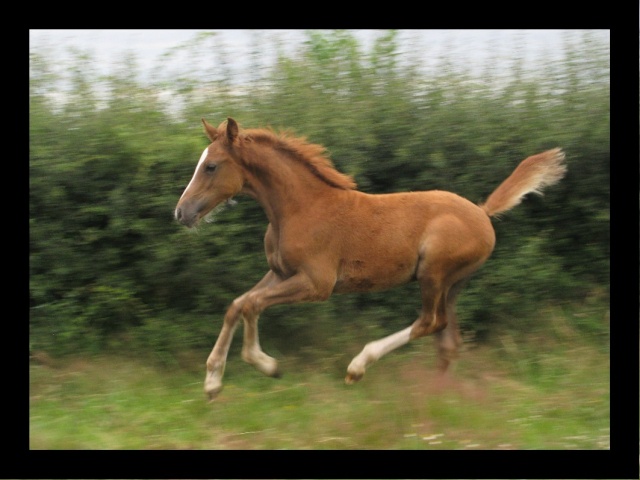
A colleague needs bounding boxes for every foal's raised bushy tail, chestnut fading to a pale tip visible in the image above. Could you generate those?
[480,148,567,217]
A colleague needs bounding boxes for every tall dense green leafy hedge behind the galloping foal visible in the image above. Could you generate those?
[29,31,610,353]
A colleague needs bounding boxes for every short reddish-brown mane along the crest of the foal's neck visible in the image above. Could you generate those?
[240,128,356,190]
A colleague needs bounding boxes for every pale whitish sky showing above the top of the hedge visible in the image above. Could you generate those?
[29,29,609,85]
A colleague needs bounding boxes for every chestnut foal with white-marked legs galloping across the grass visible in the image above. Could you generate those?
[175,118,566,400]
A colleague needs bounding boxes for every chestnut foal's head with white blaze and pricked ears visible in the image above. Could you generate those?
[175,118,244,227]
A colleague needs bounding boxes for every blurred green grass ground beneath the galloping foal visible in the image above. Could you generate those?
[30,310,610,450]
